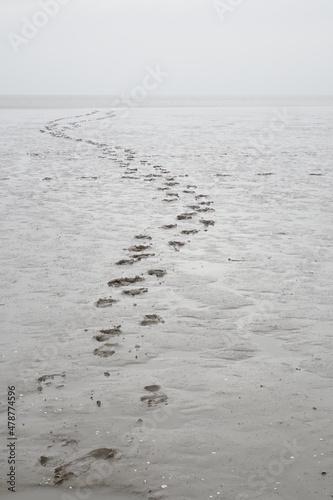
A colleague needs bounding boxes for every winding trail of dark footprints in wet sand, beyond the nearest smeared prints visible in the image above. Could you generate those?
[41,111,215,407]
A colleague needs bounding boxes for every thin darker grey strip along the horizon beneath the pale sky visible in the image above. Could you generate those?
[0,95,333,109]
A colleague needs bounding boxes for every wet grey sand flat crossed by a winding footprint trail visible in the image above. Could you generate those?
[0,110,333,500]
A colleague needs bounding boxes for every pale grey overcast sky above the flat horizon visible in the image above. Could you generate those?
[0,0,333,95]
